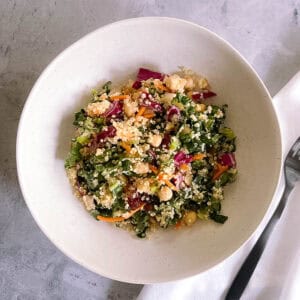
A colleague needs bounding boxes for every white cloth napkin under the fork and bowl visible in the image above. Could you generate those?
[138,72,300,300]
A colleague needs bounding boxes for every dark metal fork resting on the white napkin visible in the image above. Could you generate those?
[225,137,300,300]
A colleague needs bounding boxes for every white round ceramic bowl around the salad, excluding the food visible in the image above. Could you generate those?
[17,17,281,283]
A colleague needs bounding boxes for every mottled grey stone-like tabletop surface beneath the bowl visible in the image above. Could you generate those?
[0,0,300,300]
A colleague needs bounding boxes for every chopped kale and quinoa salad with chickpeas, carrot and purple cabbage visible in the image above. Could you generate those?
[65,68,237,238]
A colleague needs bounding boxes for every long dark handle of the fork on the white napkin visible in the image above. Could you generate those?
[225,185,293,300]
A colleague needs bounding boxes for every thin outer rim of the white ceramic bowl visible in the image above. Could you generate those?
[16,16,283,284]
